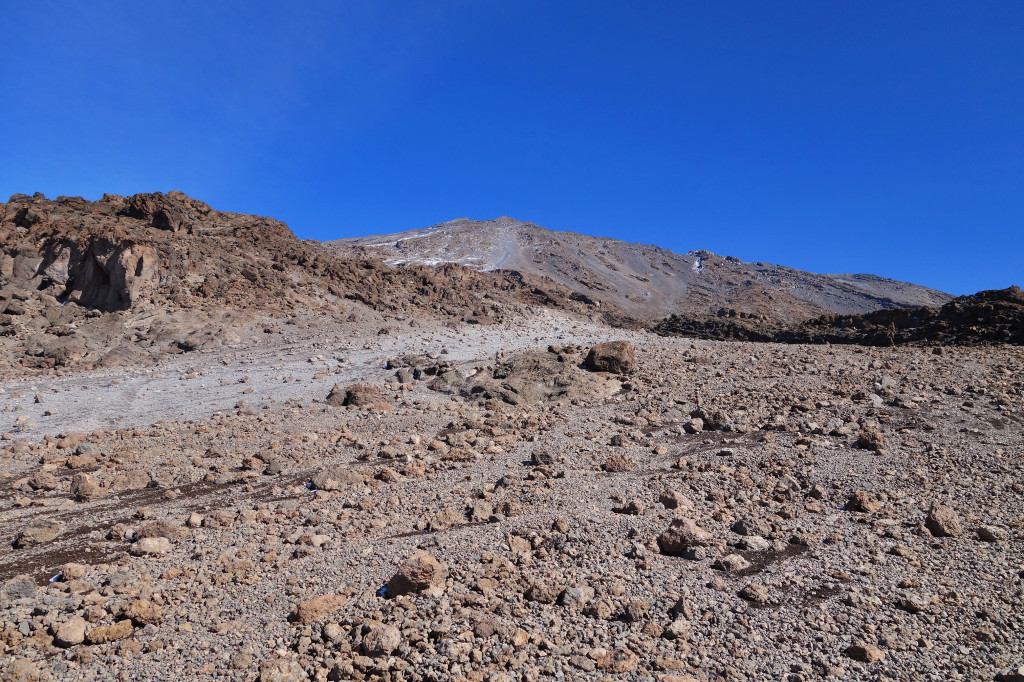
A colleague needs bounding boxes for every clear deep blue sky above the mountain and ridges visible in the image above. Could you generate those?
[0,0,1024,294]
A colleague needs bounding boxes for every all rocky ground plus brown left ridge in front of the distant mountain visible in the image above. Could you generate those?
[0,195,1024,682]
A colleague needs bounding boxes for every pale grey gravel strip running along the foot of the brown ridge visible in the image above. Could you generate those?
[0,311,647,441]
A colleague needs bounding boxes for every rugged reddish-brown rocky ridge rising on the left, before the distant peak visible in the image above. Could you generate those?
[0,193,630,373]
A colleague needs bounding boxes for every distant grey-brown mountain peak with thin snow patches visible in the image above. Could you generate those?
[327,217,951,324]
